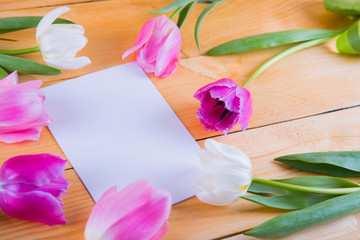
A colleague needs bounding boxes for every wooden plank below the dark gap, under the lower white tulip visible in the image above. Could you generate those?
[0,107,360,240]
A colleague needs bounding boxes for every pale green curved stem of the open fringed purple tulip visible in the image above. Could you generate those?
[242,36,336,87]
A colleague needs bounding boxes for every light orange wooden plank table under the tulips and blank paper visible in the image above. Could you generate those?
[0,0,360,240]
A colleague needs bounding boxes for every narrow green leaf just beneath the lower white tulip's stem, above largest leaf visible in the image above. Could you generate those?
[241,192,338,210]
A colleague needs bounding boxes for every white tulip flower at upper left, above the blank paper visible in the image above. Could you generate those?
[36,7,91,69]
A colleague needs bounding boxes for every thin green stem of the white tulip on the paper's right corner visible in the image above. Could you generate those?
[252,177,360,195]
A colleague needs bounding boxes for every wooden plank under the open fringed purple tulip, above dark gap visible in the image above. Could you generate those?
[153,50,360,139]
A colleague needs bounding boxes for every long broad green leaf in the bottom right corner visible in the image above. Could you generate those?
[245,191,360,239]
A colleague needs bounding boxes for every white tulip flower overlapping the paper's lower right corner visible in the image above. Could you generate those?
[196,139,252,206]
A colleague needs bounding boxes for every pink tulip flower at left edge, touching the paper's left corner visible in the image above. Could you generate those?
[0,72,51,143]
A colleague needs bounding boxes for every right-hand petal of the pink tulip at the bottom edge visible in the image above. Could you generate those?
[104,189,171,240]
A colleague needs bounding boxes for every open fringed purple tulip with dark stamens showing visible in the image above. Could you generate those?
[194,78,253,134]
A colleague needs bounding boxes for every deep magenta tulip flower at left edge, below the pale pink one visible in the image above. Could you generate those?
[0,154,69,225]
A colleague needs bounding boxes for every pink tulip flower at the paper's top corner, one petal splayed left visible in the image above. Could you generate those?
[122,15,182,77]
